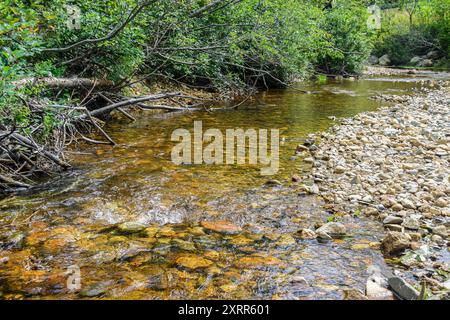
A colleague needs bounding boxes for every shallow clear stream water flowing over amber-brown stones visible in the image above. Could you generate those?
[0,74,448,299]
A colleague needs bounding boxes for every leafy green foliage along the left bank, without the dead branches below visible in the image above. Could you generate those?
[0,0,380,141]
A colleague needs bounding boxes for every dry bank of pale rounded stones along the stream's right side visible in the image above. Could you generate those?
[297,82,450,299]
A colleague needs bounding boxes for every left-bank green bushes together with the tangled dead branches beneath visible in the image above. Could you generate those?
[0,0,373,189]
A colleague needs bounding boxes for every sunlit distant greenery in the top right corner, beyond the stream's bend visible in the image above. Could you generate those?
[374,0,450,68]
